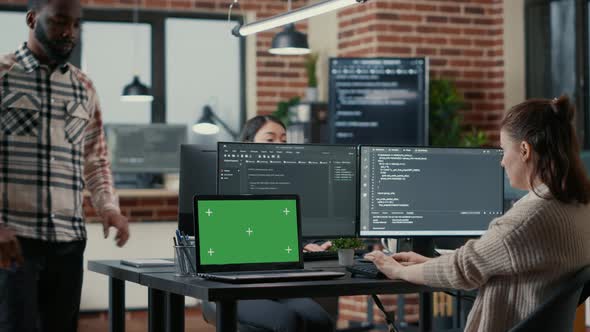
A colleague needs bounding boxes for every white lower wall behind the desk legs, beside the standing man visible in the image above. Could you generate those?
[80,222,197,311]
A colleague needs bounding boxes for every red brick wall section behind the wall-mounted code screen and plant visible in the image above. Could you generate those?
[339,0,504,144]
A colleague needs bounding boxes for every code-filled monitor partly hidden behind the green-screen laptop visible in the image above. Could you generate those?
[218,143,358,238]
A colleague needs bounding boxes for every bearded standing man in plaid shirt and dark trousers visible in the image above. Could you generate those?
[0,0,129,332]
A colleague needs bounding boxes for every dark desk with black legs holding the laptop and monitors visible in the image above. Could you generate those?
[88,261,439,332]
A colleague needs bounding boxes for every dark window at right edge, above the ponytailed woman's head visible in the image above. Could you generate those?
[525,0,590,149]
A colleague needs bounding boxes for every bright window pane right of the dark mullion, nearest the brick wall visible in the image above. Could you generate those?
[165,18,243,144]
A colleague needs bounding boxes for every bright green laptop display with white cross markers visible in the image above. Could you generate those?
[197,199,299,265]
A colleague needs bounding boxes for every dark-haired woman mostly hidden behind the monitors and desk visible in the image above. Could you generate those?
[203,115,337,332]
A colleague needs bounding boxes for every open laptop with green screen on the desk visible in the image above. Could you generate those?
[193,195,345,283]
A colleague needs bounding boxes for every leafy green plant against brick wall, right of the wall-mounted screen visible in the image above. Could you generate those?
[429,79,488,147]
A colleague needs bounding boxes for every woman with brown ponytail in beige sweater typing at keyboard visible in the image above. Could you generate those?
[366,97,590,331]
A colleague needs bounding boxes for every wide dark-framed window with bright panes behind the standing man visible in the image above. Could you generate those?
[0,5,245,132]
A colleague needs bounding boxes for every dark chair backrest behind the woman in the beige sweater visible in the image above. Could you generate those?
[510,265,590,332]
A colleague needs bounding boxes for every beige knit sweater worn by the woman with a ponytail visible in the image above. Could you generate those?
[423,186,590,332]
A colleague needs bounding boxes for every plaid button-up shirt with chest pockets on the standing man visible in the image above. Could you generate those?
[0,43,119,242]
